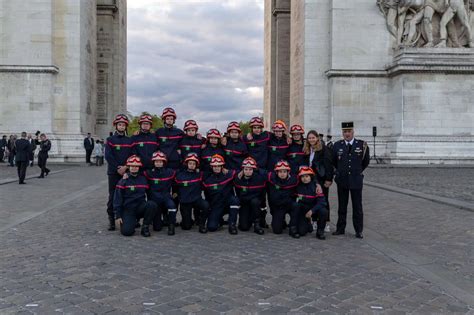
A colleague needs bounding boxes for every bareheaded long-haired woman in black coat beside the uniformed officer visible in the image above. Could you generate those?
[303,130,334,232]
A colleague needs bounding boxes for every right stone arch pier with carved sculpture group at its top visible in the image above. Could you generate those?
[264,0,474,164]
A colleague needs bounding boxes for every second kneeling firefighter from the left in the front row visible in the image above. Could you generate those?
[143,151,177,235]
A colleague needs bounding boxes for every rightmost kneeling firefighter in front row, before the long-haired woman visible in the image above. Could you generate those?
[290,166,327,240]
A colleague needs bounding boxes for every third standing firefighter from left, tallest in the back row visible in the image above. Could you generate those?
[156,107,184,171]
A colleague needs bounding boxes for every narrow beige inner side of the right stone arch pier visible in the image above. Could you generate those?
[264,0,291,127]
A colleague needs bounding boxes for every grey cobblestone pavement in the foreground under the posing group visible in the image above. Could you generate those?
[0,167,474,314]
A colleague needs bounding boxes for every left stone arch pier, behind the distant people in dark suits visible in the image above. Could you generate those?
[0,0,126,161]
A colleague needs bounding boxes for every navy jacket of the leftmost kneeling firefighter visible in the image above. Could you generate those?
[113,175,149,219]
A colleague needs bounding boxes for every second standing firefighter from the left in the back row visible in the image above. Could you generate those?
[132,114,159,170]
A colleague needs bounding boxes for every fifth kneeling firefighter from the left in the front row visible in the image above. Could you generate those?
[234,157,266,235]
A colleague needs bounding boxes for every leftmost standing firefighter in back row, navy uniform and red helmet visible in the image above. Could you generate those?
[105,114,132,231]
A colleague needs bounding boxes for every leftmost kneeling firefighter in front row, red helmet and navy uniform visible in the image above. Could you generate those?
[113,155,157,237]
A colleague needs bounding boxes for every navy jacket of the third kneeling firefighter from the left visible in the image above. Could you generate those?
[174,170,203,203]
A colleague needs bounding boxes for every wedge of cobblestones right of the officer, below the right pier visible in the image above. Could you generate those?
[365,167,474,203]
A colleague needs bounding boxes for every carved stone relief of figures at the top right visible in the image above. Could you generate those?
[377,0,474,48]
